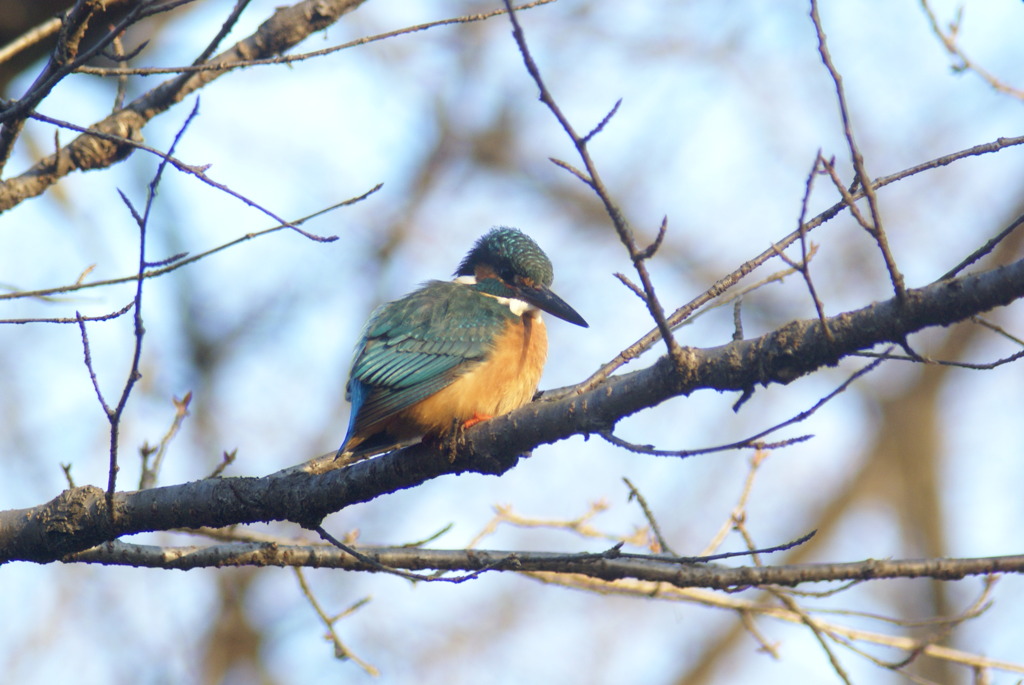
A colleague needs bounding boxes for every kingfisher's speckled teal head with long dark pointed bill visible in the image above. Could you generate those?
[455,226,589,328]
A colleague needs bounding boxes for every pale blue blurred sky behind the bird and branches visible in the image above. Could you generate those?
[0,0,1024,683]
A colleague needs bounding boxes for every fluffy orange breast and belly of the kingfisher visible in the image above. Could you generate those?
[401,310,548,433]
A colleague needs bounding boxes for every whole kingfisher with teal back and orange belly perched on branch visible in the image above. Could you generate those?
[336,226,589,462]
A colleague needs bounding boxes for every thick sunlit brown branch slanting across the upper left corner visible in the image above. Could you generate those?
[0,0,365,212]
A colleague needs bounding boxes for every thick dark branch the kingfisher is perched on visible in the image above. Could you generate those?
[0,255,1024,562]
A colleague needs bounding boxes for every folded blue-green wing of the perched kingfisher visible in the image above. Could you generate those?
[346,281,515,441]
